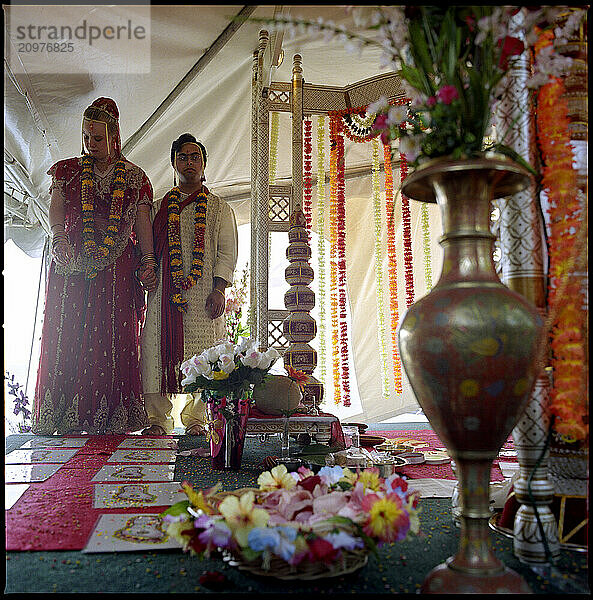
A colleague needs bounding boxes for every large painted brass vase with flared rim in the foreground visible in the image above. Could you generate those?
[398,155,543,593]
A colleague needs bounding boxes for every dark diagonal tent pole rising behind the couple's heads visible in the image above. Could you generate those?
[122,4,257,153]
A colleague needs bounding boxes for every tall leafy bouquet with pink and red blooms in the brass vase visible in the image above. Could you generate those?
[255,5,586,172]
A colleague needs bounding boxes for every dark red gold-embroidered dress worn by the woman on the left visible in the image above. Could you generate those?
[33,158,152,435]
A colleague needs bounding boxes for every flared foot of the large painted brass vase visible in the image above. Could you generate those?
[420,563,533,594]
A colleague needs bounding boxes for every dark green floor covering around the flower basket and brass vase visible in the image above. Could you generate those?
[5,432,589,598]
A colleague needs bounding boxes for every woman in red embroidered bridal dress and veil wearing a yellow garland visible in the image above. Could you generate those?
[32,98,156,435]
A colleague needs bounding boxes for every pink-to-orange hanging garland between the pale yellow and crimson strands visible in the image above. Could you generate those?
[329,118,342,404]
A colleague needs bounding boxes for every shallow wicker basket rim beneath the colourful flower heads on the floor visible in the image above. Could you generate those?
[216,487,369,580]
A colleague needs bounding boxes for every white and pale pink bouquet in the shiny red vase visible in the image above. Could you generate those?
[181,338,280,398]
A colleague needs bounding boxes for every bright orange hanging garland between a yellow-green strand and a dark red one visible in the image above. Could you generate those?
[383,144,402,394]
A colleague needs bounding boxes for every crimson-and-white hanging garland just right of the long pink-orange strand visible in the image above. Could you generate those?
[336,125,350,406]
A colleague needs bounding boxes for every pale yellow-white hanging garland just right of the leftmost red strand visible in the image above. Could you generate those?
[317,116,327,384]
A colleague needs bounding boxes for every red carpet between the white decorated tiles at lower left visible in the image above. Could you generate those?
[5,435,176,550]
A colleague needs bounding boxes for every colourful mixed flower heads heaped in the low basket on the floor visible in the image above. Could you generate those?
[163,464,420,578]
